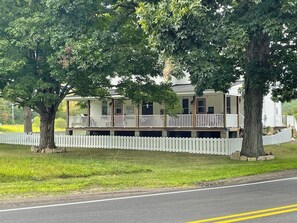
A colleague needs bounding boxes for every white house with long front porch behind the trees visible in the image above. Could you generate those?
[66,76,283,138]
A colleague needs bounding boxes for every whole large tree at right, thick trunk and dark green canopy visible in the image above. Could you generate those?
[138,0,297,157]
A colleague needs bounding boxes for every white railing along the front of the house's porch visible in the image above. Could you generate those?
[69,114,243,128]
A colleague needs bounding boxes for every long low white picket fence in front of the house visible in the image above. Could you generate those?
[0,128,291,155]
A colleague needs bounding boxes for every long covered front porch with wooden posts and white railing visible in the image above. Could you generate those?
[67,92,243,137]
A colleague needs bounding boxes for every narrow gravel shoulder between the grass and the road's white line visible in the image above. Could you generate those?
[0,169,297,209]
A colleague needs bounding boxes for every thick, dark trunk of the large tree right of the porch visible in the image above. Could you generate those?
[241,32,270,157]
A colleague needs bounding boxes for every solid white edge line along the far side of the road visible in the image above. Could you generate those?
[0,177,297,213]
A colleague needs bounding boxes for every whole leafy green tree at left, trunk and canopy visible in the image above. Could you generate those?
[0,0,177,151]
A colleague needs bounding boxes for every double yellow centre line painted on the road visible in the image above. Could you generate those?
[188,204,297,223]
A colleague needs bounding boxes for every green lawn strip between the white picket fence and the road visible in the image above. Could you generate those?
[0,143,297,199]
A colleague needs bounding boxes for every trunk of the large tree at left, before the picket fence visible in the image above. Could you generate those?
[39,110,57,151]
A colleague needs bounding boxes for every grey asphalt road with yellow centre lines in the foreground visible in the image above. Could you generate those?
[0,177,297,223]
